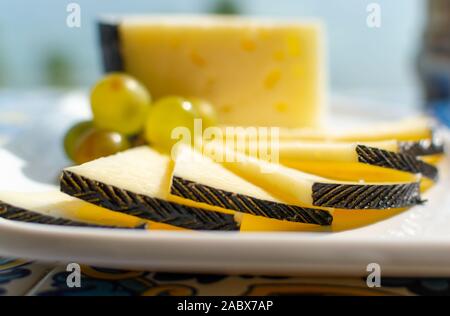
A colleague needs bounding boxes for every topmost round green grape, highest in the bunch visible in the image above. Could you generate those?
[91,73,151,135]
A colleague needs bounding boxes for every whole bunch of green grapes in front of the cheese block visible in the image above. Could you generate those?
[64,73,217,164]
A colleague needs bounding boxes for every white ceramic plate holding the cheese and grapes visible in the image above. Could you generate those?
[0,91,450,277]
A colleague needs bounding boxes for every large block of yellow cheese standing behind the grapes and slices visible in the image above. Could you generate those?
[100,15,324,127]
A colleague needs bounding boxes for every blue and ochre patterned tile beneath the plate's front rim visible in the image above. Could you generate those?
[25,266,431,296]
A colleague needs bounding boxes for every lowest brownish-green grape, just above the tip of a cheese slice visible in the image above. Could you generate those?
[74,129,130,164]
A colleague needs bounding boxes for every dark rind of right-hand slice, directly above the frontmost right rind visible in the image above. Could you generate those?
[356,145,438,180]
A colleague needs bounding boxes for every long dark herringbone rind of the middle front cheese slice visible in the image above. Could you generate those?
[170,176,333,225]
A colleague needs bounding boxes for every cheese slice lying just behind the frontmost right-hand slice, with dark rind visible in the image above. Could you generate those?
[230,141,438,182]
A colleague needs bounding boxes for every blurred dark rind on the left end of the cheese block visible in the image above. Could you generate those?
[98,22,124,72]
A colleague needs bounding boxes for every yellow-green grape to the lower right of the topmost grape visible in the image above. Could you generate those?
[145,96,199,150]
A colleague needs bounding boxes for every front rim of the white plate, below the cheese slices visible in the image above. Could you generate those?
[0,219,450,277]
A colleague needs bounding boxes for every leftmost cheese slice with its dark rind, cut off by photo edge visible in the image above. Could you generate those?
[0,191,150,229]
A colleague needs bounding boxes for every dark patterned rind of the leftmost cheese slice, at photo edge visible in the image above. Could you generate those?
[0,201,147,229]
